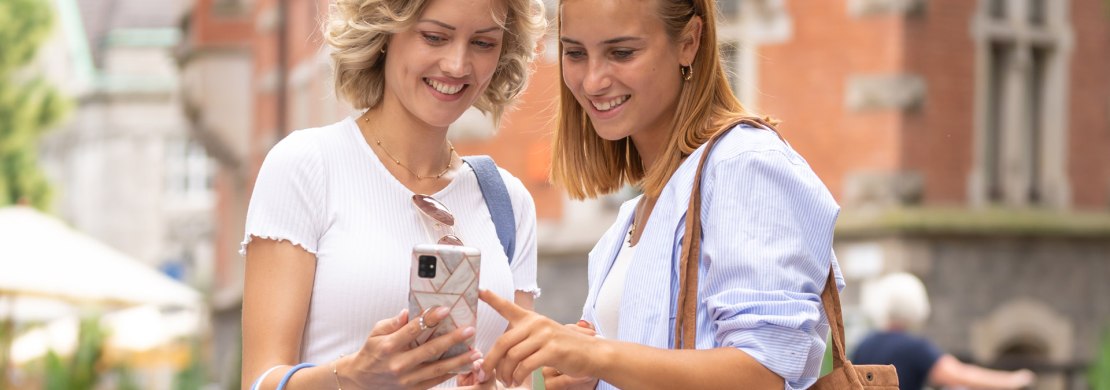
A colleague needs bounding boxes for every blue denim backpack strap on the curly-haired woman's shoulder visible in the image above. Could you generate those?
[463,156,516,263]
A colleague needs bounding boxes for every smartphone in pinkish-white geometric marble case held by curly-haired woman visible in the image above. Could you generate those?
[408,244,482,366]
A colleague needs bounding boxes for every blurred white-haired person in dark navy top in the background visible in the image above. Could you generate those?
[850,272,1036,390]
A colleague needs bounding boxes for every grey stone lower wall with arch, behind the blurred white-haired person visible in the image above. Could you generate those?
[837,233,1110,389]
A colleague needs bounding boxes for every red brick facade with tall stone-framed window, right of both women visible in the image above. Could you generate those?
[758,0,1110,210]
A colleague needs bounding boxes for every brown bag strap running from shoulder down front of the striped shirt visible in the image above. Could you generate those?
[674,117,781,349]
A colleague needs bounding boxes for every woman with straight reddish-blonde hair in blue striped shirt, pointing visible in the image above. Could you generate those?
[481,0,842,389]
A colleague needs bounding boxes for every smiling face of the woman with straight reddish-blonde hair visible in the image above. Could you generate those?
[559,0,693,148]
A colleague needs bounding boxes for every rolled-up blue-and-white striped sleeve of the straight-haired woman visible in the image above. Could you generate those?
[700,149,839,389]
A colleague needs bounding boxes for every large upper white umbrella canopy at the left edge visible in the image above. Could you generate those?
[0,207,201,316]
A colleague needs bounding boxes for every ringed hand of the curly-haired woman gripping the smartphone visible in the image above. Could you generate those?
[335,308,482,390]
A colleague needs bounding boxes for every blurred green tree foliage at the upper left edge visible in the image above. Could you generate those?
[0,0,69,209]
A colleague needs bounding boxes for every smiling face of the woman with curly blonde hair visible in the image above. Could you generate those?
[383,0,507,128]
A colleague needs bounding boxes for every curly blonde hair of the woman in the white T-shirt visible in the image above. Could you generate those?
[324,0,547,121]
